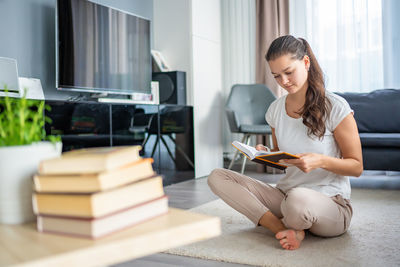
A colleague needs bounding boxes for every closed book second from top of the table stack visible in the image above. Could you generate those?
[33,158,155,193]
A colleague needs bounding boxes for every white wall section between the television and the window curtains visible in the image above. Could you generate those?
[153,0,224,178]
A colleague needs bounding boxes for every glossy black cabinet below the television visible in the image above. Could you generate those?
[46,100,194,185]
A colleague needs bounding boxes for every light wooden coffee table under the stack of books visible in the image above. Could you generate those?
[0,208,221,267]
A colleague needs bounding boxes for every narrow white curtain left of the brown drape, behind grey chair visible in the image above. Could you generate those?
[221,0,256,157]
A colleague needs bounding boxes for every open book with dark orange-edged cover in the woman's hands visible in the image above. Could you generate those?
[232,141,299,170]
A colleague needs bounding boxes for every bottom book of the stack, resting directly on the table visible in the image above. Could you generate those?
[37,196,168,239]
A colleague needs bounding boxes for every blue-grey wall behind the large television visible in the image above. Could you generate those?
[0,0,153,99]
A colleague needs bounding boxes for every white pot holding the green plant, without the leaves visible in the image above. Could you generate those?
[0,142,62,224]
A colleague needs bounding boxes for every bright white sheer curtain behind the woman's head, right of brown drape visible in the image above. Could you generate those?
[289,0,384,92]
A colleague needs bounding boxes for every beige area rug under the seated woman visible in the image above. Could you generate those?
[166,189,400,267]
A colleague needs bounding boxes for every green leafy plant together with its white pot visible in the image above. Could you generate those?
[0,90,62,224]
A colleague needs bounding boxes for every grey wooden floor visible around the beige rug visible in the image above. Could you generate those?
[115,164,400,267]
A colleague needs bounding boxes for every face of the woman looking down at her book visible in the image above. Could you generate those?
[268,54,310,94]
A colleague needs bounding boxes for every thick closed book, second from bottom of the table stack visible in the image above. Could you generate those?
[33,176,164,218]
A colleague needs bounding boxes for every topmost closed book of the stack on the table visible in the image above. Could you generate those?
[39,146,141,175]
